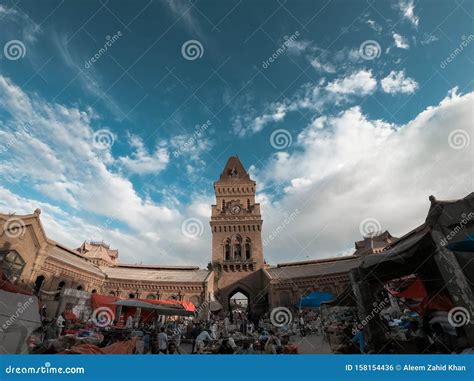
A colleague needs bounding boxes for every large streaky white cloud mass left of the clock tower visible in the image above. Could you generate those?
[0,76,209,264]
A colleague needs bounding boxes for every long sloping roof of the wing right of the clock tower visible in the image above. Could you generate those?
[266,255,361,279]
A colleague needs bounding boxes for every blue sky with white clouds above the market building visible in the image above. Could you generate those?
[0,0,474,267]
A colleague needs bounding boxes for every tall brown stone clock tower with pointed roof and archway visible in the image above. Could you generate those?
[210,156,264,312]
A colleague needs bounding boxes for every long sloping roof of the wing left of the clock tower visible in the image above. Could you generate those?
[101,266,209,283]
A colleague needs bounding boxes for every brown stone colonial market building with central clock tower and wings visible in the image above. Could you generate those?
[0,156,395,315]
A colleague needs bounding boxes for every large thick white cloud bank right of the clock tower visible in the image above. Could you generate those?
[259,91,474,263]
